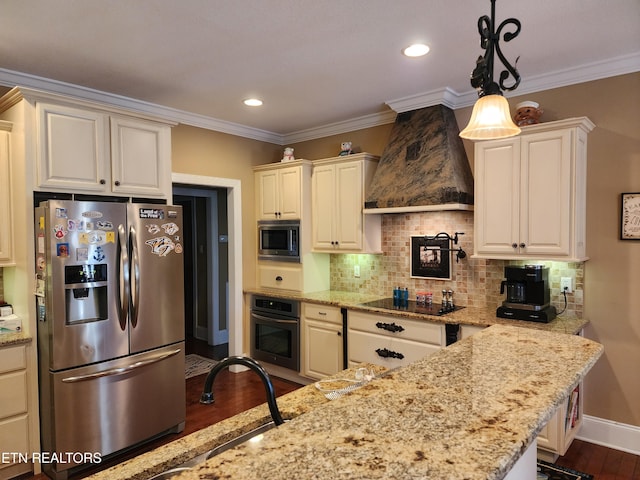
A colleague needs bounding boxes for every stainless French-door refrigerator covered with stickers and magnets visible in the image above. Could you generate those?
[35,200,186,479]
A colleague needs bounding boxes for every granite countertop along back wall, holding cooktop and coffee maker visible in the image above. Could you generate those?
[245,289,589,334]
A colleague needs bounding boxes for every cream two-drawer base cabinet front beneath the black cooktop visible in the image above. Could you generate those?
[347,310,446,368]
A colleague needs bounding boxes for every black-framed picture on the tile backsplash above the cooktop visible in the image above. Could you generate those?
[411,236,451,280]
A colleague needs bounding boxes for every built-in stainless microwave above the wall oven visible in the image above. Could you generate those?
[258,220,300,262]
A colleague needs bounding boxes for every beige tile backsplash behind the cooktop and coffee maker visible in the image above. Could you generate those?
[331,211,584,317]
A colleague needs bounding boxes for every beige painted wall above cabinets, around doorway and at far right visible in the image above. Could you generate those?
[166,73,640,426]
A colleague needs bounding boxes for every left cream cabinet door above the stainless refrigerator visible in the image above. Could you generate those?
[36,102,111,193]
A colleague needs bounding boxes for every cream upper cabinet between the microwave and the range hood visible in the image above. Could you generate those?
[311,153,382,253]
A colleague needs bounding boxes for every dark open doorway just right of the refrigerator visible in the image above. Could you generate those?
[173,185,229,359]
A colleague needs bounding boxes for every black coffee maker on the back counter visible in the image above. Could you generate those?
[496,265,556,323]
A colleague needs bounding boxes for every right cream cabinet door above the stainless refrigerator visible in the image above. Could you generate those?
[111,117,171,196]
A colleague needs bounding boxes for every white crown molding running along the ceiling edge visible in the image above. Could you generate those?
[0,52,640,145]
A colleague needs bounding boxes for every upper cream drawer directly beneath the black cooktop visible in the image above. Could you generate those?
[348,310,446,347]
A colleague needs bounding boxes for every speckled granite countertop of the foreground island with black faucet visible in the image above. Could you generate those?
[91,325,603,480]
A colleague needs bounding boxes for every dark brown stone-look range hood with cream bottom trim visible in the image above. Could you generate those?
[364,105,473,213]
